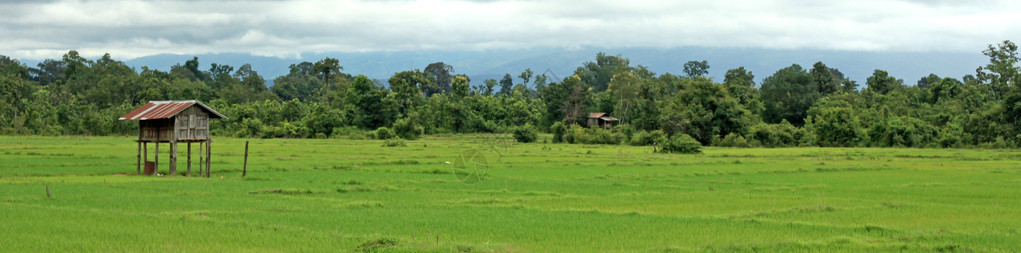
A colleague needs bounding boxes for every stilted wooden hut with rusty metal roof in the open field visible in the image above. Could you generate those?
[119,100,227,178]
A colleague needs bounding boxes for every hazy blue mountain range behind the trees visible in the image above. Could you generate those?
[17,47,988,87]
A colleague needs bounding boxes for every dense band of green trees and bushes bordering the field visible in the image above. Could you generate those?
[0,41,1021,148]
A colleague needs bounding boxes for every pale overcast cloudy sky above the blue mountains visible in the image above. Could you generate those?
[0,0,1021,59]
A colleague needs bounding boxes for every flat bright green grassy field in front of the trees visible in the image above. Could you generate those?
[0,136,1021,252]
